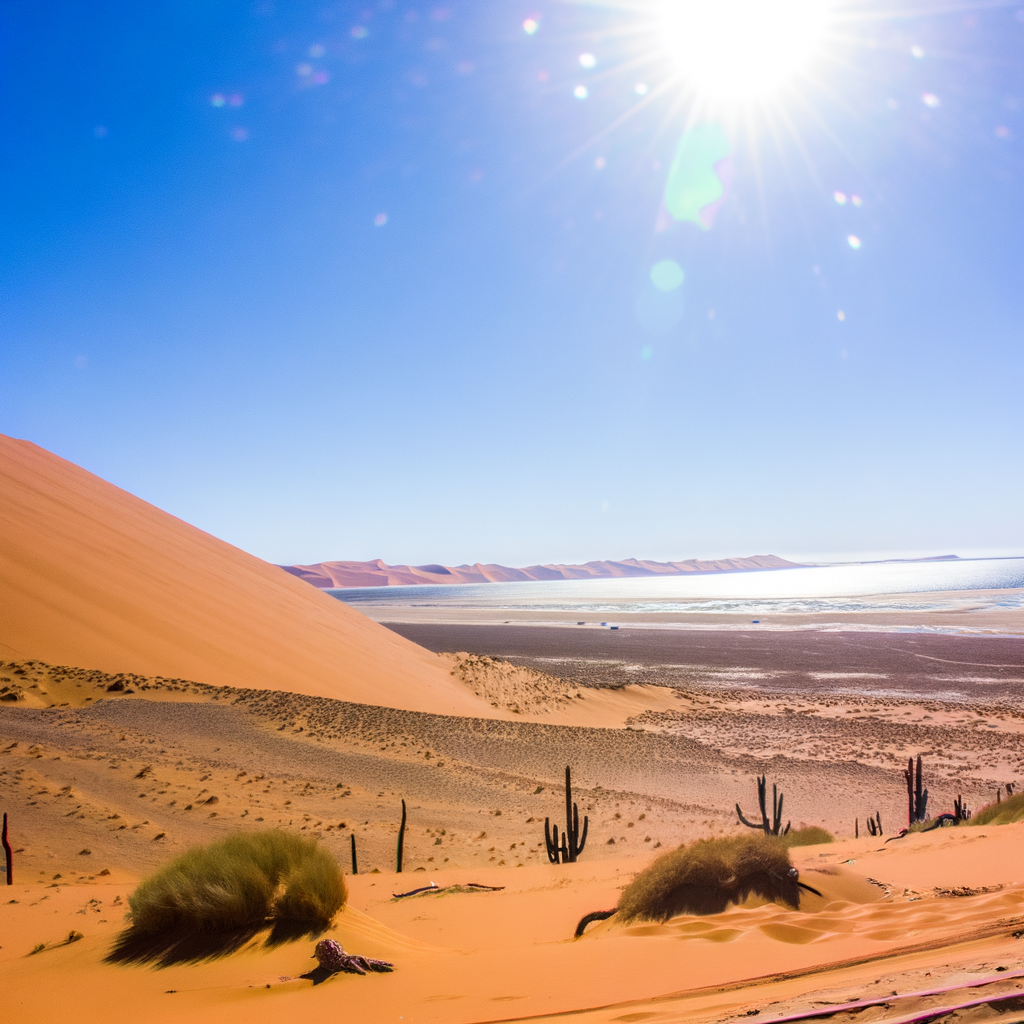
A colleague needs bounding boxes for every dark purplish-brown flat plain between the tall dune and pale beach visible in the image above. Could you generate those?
[385,623,1024,706]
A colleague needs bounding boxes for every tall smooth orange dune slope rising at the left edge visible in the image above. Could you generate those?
[0,434,495,716]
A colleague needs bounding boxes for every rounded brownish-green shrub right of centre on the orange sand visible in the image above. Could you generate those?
[618,836,800,922]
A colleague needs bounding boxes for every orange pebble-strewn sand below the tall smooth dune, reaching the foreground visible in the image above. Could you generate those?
[0,653,1024,1024]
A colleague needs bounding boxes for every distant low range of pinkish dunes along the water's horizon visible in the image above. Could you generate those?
[281,555,799,590]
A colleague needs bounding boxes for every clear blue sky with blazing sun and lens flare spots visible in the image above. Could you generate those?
[0,0,1024,565]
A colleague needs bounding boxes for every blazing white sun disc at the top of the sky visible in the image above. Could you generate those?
[660,0,828,100]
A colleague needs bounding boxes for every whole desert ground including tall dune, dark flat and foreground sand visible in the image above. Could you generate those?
[0,439,1024,1024]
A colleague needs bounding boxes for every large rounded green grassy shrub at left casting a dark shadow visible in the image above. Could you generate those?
[128,829,348,934]
